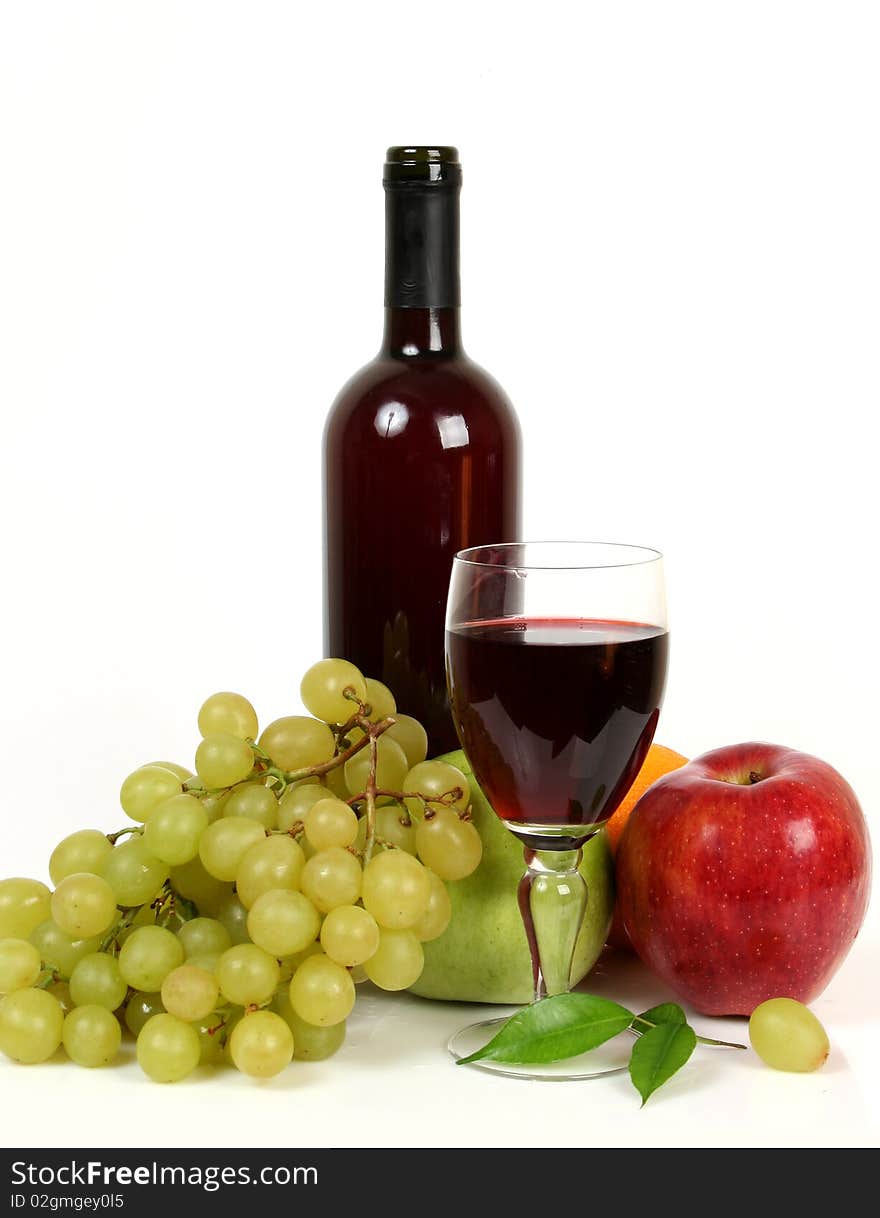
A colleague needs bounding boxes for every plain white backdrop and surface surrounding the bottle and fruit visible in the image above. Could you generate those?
[0,0,880,1146]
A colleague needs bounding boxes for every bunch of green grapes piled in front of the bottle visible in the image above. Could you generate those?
[0,659,481,1083]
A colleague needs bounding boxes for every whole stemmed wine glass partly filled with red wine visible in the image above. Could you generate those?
[446,542,668,1078]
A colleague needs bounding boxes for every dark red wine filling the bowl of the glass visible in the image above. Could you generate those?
[446,618,668,840]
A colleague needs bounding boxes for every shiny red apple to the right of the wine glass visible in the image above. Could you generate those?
[617,744,870,1015]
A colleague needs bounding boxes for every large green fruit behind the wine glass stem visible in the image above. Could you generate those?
[411,750,606,1004]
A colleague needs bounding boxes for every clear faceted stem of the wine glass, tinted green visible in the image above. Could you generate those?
[518,845,587,1002]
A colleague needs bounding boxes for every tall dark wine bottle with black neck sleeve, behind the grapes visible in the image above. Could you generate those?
[324,147,520,755]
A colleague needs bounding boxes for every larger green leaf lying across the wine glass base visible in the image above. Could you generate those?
[458,994,633,1066]
